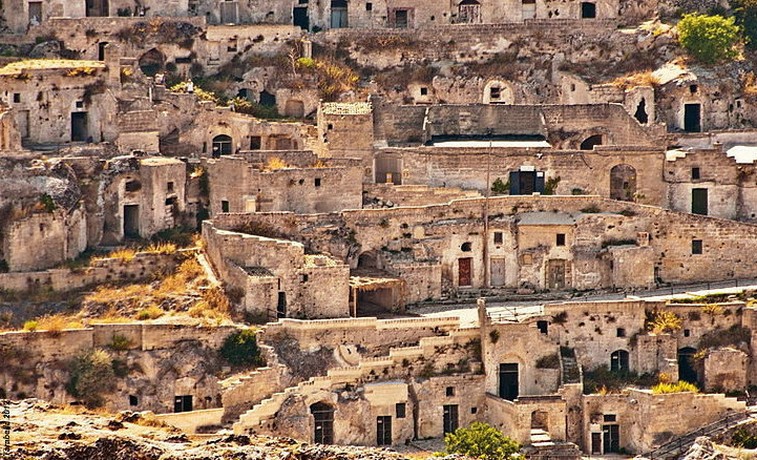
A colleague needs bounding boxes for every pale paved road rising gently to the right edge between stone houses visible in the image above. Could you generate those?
[410,279,757,327]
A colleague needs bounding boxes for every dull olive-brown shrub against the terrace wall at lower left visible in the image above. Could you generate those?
[66,349,116,407]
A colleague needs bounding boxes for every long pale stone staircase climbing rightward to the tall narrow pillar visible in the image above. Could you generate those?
[234,329,479,434]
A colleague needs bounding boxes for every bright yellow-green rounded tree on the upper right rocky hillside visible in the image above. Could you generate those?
[678,13,740,64]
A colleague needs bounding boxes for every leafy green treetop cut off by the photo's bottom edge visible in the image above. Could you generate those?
[444,422,523,460]
